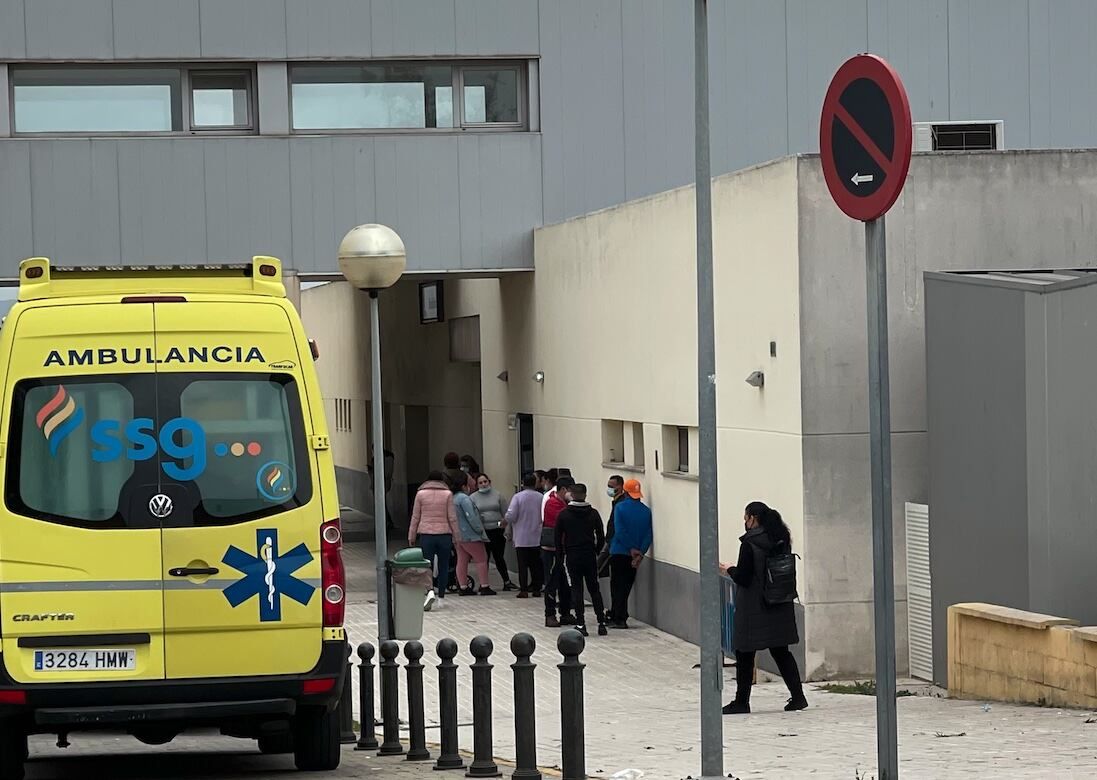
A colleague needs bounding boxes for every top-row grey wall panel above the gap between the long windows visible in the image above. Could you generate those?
[200,0,286,59]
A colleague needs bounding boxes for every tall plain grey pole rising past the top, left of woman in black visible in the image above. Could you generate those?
[693,0,724,778]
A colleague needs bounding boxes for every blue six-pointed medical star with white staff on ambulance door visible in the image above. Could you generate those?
[222,529,316,623]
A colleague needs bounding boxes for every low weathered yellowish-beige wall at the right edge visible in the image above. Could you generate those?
[948,603,1097,710]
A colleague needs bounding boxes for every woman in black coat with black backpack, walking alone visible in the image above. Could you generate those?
[720,501,807,715]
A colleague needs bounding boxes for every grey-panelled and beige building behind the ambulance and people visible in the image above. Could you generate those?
[0,0,1097,677]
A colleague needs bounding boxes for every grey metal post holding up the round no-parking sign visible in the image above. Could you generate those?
[864,216,898,780]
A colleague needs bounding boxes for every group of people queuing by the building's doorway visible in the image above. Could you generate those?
[408,452,652,635]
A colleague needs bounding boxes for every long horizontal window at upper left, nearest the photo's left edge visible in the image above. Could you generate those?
[11,66,255,134]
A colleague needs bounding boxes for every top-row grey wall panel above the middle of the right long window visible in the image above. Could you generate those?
[371,0,457,57]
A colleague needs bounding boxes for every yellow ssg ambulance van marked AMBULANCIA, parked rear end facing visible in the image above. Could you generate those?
[0,257,348,780]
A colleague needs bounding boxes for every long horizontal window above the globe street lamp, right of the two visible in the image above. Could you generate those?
[290,61,527,132]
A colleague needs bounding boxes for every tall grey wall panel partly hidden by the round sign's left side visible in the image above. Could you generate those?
[785,0,869,151]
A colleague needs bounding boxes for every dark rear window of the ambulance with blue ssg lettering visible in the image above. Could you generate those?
[4,373,313,529]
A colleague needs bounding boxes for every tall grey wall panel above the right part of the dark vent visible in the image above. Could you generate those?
[948,0,1030,147]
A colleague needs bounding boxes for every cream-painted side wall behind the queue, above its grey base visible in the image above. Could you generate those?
[502,160,803,570]
